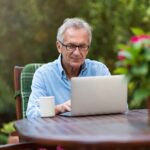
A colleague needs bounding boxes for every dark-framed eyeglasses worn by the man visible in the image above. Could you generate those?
[59,41,89,52]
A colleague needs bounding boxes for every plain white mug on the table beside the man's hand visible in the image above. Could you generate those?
[39,96,55,117]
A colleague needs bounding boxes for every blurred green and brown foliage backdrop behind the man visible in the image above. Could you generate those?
[0,0,150,139]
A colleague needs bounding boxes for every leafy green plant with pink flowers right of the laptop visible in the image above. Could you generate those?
[115,28,150,108]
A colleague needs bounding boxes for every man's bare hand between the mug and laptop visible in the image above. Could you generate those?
[55,100,71,114]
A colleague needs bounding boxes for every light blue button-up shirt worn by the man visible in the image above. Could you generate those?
[26,56,110,118]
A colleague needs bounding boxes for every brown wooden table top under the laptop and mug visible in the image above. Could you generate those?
[15,109,150,146]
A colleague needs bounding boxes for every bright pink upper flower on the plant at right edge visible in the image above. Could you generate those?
[130,34,150,43]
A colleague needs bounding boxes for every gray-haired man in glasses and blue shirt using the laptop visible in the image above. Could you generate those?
[27,18,110,118]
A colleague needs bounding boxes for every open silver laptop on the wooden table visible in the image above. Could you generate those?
[61,75,128,116]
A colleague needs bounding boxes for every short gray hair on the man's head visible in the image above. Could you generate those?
[57,18,92,45]
